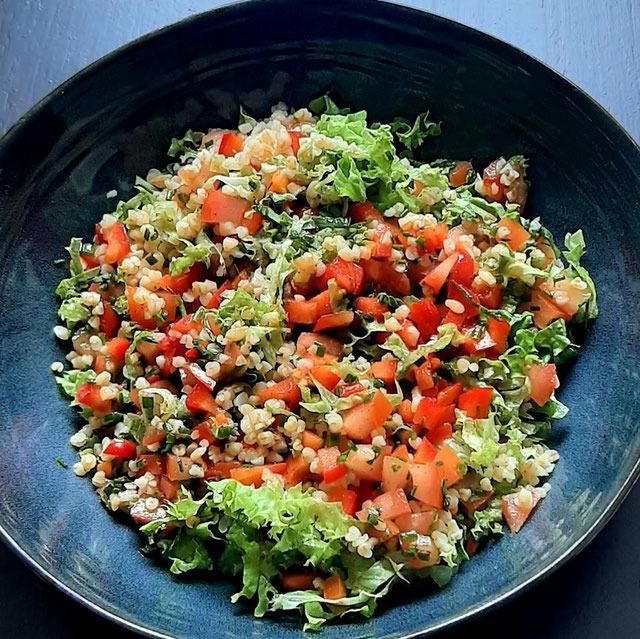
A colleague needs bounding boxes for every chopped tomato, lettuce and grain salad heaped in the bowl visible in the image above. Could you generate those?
[52,97,597,629]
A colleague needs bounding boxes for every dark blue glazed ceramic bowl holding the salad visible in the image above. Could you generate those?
[0,0,640,639]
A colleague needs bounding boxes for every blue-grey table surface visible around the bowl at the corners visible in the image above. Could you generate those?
[0,0,640,639]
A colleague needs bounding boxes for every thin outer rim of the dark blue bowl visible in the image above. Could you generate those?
[0,0,640,639]
